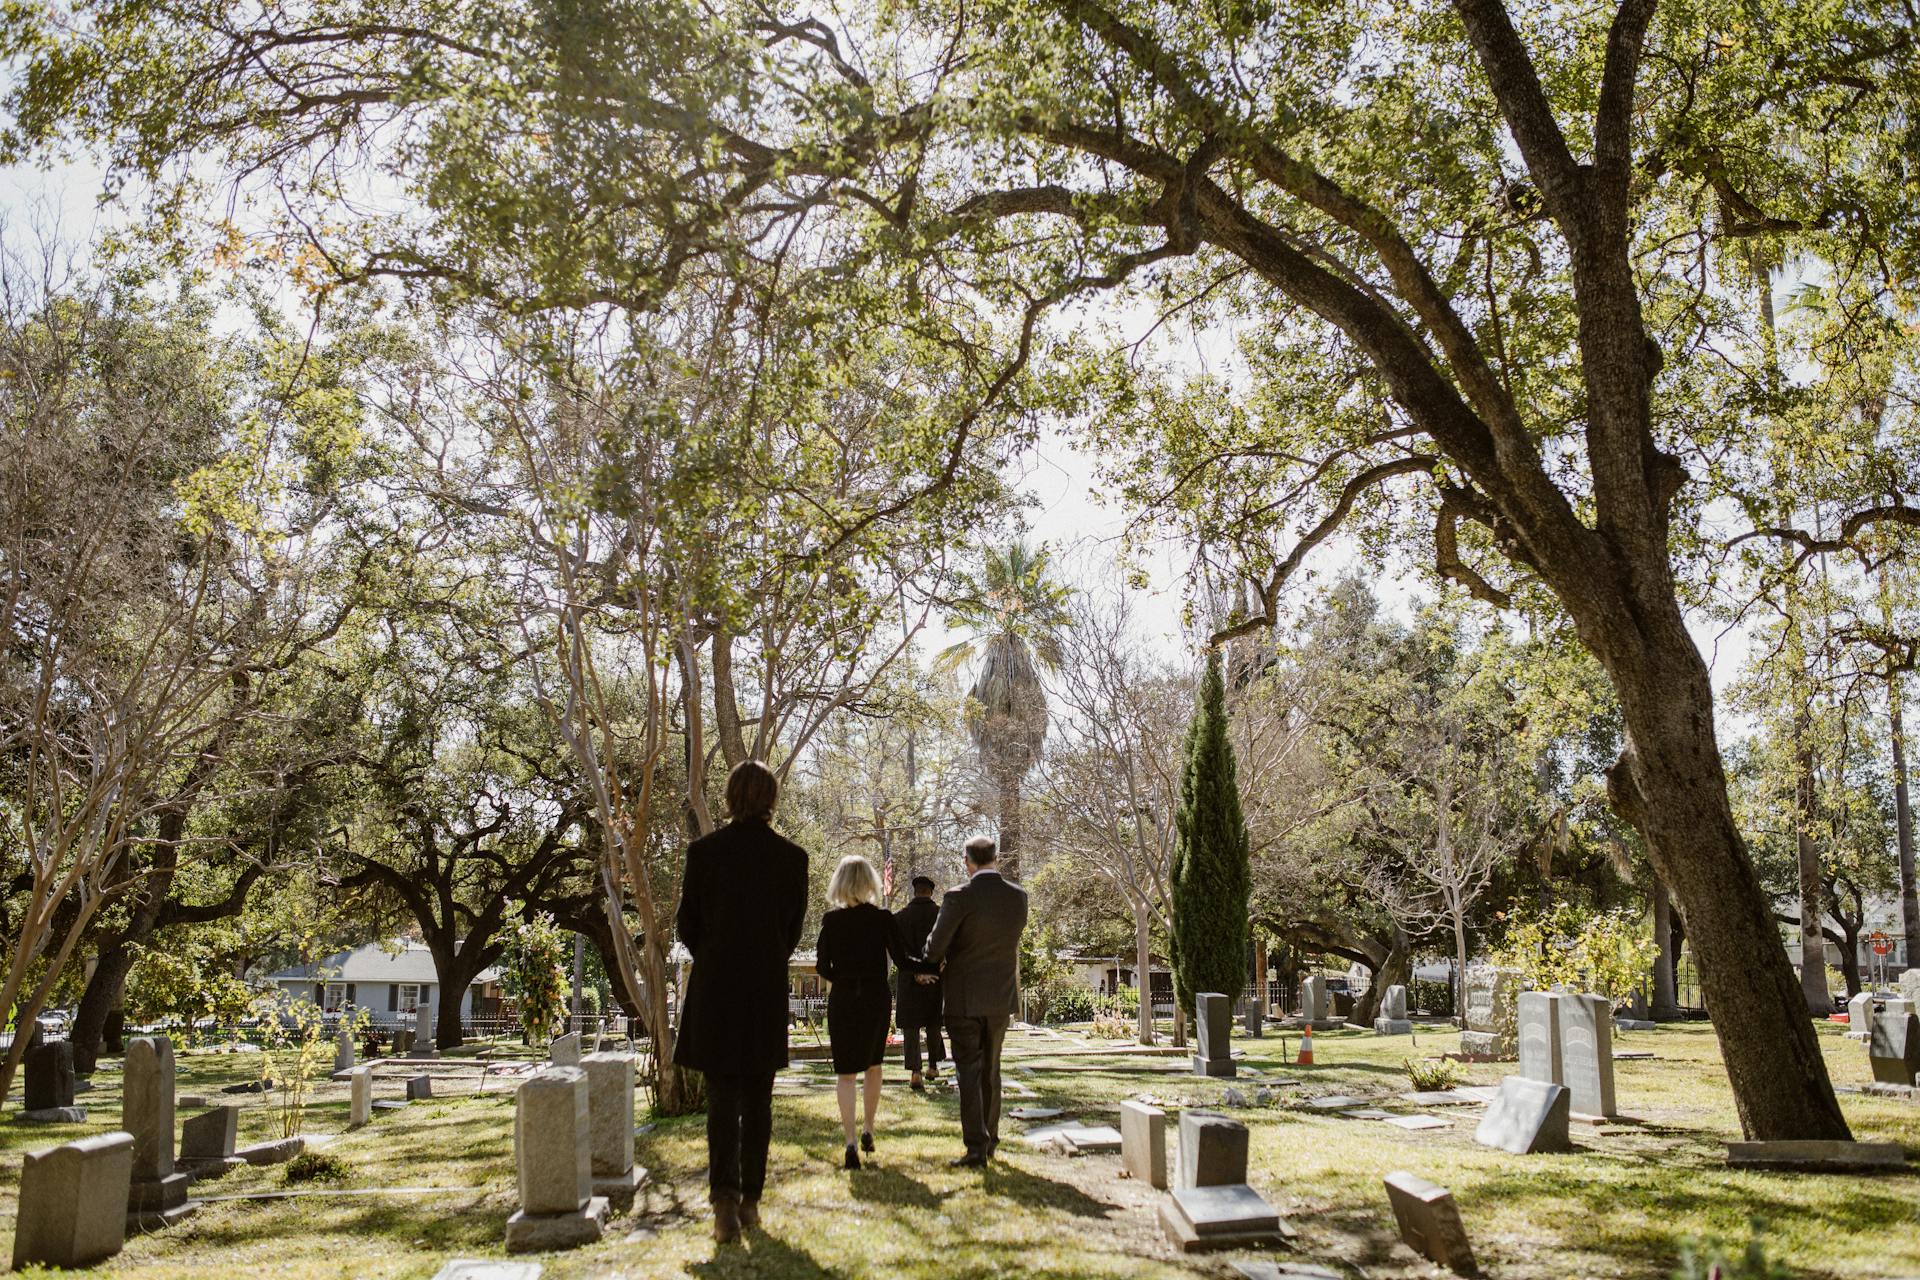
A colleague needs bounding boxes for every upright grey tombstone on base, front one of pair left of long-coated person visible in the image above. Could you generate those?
[507,1067,607,1253]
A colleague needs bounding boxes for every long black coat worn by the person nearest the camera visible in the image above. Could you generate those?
[674,819,806,1075]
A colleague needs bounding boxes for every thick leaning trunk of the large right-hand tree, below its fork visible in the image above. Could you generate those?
[1605,637,1851,1140]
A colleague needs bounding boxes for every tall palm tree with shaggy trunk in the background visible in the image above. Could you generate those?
[939,537,1071,877]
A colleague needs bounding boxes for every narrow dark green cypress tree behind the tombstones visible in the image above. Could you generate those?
[1173,651,1252,1013]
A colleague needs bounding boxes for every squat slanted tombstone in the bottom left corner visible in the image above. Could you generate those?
[13,1132,132,1270]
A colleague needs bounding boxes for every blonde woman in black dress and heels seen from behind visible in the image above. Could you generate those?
[814,854,922,1169]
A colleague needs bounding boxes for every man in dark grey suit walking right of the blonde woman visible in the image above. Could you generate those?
[927,837,1027,1169]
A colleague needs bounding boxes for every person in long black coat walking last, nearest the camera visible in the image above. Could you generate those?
[674,760,806,1244]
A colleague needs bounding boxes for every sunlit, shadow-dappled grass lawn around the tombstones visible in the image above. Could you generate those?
[0,1025,1920,1280]
